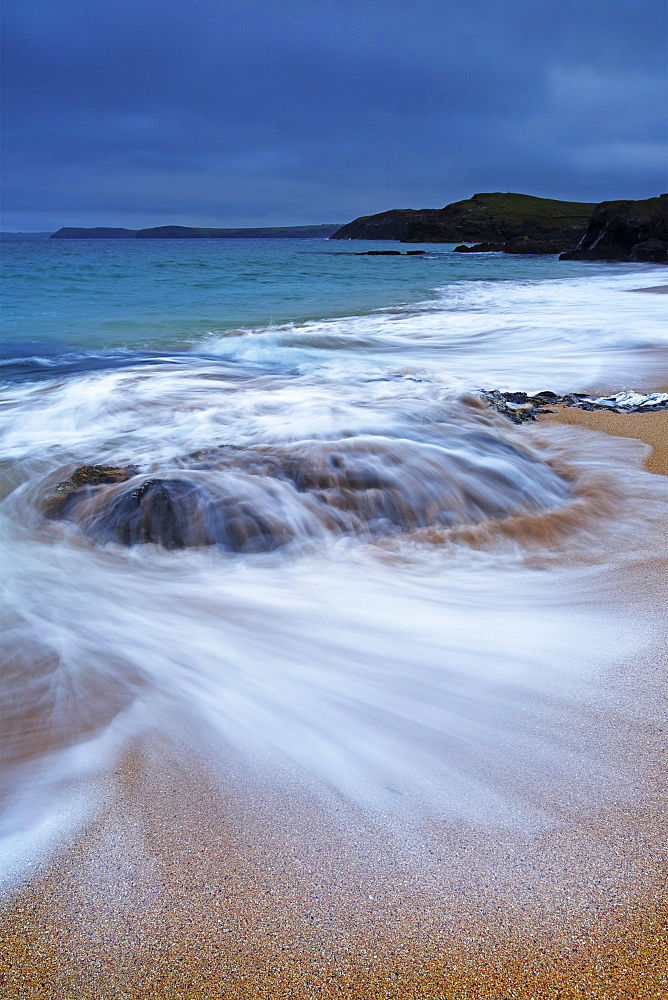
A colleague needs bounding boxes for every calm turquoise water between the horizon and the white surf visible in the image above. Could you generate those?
[2,240,612,353]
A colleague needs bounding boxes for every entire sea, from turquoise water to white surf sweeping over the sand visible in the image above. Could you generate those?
[0,240,668,883]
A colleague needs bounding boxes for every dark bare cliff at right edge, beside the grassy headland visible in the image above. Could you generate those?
[561,194,668,264]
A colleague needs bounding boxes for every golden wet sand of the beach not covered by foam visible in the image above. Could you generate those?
[0,409,668,1000]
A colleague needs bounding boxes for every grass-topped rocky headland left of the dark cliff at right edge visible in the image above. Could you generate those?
[331,192,595,244]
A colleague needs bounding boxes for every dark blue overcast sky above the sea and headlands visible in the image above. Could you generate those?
[2,0,666,230]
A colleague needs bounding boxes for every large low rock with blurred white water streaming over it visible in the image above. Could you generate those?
[45,432,568,553]
